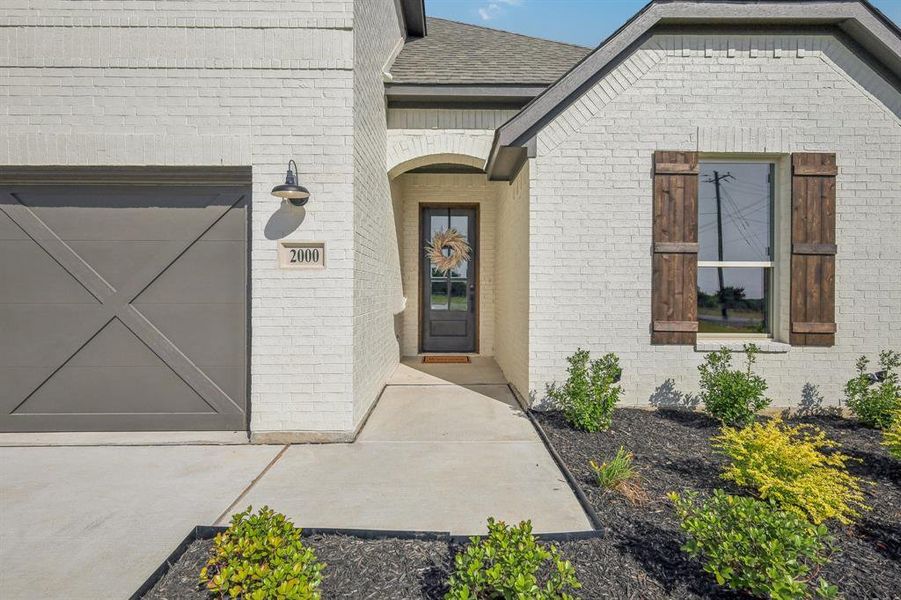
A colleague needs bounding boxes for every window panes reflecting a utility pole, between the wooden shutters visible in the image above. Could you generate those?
[698,161,775,337]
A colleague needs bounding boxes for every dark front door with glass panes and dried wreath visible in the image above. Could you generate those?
[419,206,479,352]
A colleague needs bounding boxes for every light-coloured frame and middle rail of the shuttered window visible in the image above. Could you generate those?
[697,153,790,341]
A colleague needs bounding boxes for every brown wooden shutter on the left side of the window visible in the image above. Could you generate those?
[651,152,698,344]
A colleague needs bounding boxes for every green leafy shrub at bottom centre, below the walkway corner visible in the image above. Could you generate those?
[445,518,581,600]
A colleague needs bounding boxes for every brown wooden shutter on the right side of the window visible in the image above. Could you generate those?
[789,152,837,346]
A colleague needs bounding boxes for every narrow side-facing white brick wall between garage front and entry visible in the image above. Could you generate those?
[353,0,403,425]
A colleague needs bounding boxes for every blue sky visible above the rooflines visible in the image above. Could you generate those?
[425,0,901,48]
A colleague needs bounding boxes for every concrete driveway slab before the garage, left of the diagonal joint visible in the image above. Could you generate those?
[0,445,282,600]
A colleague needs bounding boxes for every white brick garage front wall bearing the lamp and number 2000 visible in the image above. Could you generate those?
[0,0,358,431]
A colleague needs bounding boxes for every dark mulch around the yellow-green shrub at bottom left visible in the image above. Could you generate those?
[144,535,453,600]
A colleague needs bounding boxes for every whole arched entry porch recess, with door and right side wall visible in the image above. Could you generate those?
[389,154,529,397]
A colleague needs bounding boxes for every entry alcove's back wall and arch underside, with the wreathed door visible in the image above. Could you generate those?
[389,154,496,356]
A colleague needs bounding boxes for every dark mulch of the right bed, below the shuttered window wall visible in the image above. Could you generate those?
[536,409,901,599]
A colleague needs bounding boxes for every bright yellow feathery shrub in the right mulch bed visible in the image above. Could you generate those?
[712,419,867,524]
